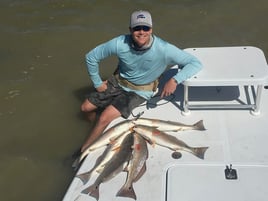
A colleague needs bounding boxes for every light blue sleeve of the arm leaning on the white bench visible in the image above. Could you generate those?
[167,44,203,83]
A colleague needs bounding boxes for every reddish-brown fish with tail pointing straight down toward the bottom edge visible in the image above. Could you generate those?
[116,133,148,200]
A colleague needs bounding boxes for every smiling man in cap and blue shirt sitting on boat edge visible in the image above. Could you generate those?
[81,11,202,152]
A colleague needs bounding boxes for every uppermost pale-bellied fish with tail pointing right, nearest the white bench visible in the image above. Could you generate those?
[133,118,206,131]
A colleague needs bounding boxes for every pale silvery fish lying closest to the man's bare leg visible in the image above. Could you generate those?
[72,120,134,168]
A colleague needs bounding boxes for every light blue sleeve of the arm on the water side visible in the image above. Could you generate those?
[86,38,117,88]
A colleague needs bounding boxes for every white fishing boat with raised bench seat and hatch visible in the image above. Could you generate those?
[63,46,268,201]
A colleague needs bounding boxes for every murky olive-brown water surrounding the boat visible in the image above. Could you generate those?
[0,0,268,201]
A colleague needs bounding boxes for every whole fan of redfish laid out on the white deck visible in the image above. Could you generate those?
[73,118,208,200]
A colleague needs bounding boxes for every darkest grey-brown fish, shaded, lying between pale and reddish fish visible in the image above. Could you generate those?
[82,134,134,200]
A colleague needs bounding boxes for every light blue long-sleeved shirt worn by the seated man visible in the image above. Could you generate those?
[86,35,202,99]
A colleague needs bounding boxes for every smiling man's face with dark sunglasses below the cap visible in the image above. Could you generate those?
[130,26,153,47]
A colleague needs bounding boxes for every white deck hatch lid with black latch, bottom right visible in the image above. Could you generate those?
[165,164,268,201]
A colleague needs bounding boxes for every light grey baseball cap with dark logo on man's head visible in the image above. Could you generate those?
[130,10,153,28]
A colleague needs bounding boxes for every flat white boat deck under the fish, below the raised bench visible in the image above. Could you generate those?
[64,85,268,201]
